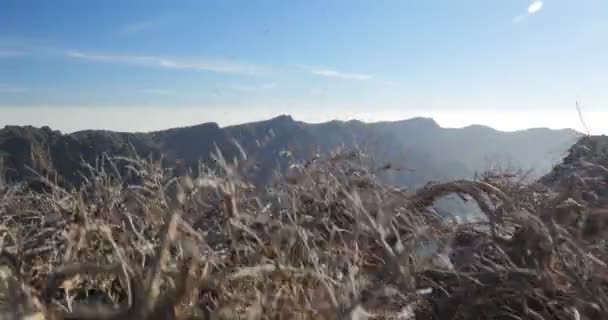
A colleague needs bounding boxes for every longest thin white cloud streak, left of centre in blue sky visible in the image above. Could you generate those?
[65,50,264,74]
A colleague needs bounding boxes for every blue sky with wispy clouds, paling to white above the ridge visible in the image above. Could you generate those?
[0,0,608,134]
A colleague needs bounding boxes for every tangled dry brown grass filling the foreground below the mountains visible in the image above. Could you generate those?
[0,144,608,320]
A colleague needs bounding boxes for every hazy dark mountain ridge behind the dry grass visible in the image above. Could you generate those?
[0,116,580,187]
